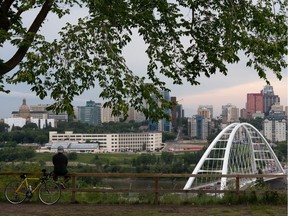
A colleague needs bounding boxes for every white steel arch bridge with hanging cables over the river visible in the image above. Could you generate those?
[184,123,285,190]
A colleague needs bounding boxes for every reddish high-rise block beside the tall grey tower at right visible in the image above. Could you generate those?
[246,93,264,119]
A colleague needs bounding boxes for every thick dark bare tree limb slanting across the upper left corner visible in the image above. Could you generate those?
[0,0,54,76]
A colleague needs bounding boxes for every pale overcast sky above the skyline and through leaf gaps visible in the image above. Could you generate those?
[0,4,288,118]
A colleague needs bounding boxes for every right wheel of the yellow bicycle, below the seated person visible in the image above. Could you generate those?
[38,181,61,205]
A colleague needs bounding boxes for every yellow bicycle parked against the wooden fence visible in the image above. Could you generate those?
[4,169,61,205]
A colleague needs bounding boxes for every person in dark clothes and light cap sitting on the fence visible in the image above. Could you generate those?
[52,146,70,188]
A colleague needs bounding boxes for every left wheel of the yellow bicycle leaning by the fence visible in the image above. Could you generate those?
[4,181,27,204]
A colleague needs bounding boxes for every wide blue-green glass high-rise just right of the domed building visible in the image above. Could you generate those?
[78,100,101,125]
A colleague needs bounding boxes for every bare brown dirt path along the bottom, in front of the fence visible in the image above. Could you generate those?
[0,203,287,216]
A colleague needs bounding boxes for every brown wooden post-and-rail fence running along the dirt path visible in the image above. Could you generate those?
[0,172,287,204]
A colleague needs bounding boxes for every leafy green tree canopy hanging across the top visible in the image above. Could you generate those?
[0,0,287,120]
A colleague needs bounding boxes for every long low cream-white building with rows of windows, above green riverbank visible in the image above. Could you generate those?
[49,131,162,152]
